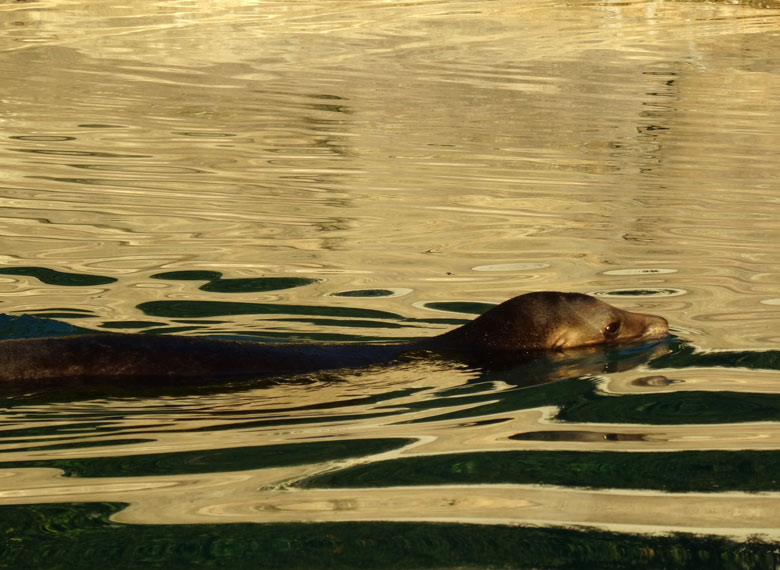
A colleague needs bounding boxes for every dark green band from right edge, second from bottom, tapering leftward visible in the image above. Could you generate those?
[298,451,780,493]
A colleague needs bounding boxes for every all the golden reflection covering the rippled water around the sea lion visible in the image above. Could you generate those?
[0,0,780,536]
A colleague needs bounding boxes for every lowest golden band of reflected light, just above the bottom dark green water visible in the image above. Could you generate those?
[6,467,780,539]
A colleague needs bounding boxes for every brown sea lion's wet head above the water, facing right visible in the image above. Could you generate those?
[437,291,669,351]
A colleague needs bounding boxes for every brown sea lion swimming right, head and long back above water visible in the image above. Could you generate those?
[0,292,669,393]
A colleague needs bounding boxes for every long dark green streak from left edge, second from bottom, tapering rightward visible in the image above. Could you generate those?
[0,438,414,477]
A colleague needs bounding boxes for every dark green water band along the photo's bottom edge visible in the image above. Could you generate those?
[0,503,780,570]
